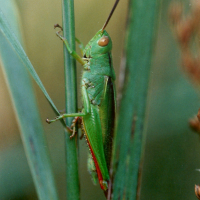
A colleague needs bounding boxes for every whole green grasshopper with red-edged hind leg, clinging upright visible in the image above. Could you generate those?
[47,0,119,191]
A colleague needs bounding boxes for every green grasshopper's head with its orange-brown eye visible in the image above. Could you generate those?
[83,29,112,58]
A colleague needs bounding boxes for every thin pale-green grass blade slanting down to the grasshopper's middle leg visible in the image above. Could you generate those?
[0,10,59,120]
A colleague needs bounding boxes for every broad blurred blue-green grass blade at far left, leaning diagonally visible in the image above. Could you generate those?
[0,1,58,200]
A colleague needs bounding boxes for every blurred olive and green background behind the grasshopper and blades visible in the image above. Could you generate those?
[0,0,200,200]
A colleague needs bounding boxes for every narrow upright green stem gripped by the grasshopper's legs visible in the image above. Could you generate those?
[62,0,79,200]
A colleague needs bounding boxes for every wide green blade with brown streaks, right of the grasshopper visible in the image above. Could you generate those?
[113,0,158,200]
